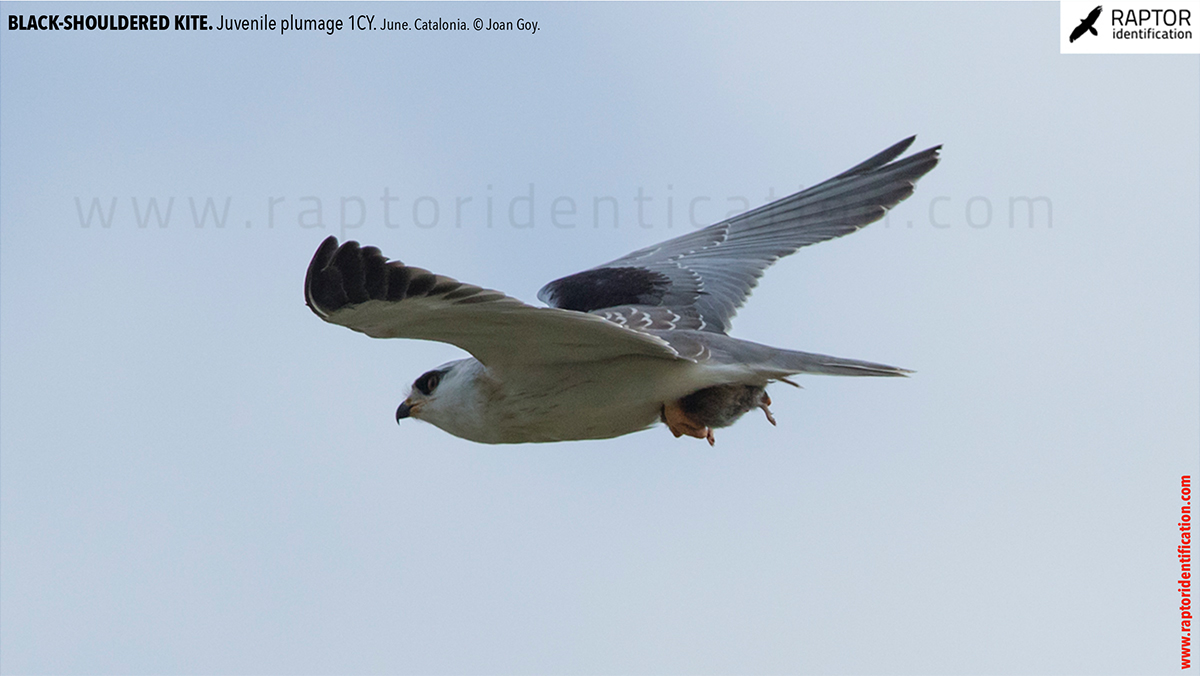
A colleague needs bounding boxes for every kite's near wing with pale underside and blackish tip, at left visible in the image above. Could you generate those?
[304,237,678,371]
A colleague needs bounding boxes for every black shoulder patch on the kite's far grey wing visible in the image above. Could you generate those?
[538,268,671,312]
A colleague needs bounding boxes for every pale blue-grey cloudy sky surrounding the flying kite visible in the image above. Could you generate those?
[0,2,1200,674]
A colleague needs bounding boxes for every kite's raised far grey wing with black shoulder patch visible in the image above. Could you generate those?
[538,137,941,333]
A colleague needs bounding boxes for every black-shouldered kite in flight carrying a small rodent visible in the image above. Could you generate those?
[305,137,941,444]
